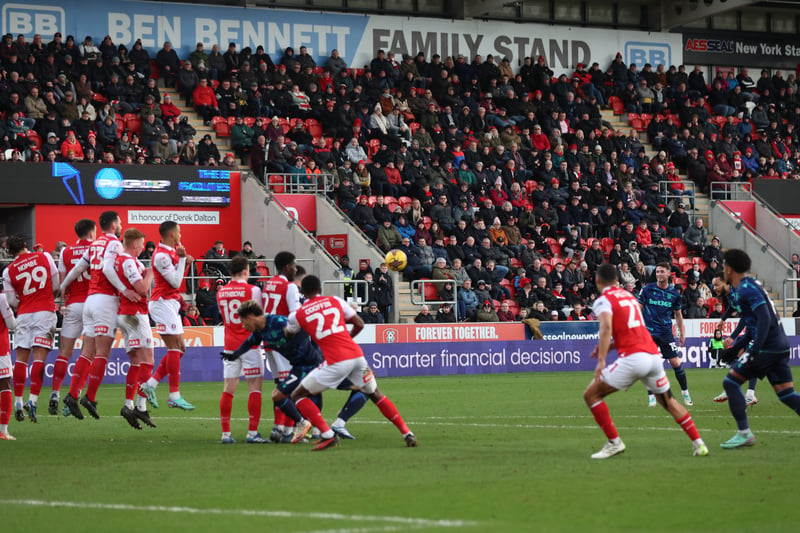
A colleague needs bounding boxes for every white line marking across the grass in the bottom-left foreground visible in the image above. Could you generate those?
[0,500,478,533]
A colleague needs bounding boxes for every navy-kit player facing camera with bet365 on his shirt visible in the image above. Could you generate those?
[639,263,692,407]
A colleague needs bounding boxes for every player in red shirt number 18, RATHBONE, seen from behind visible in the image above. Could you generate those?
[217,255,269,444]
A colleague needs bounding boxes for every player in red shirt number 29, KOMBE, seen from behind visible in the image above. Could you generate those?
[3,236,58,422]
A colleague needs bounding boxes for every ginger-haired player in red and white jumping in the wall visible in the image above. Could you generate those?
[114,228,156,429]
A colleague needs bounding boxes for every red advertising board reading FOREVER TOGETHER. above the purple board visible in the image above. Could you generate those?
[375,322,525,344]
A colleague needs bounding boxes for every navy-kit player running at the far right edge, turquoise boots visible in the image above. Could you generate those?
[721,249,800,449]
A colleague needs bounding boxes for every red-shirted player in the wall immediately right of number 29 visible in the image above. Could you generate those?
[47,218,97,415]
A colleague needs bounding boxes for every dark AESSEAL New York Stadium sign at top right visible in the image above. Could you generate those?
[683,30,800,69]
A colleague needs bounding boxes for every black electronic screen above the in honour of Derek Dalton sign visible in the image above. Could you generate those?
[0,163,234,207]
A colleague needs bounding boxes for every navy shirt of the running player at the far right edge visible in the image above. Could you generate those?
[728,277,789,356]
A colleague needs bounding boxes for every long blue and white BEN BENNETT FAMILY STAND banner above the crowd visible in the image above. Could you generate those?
[0,0,683,73]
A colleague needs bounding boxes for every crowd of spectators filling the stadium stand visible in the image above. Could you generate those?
[0,34,800,320]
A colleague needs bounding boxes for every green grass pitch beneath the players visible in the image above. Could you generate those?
[0,370,800,533]
